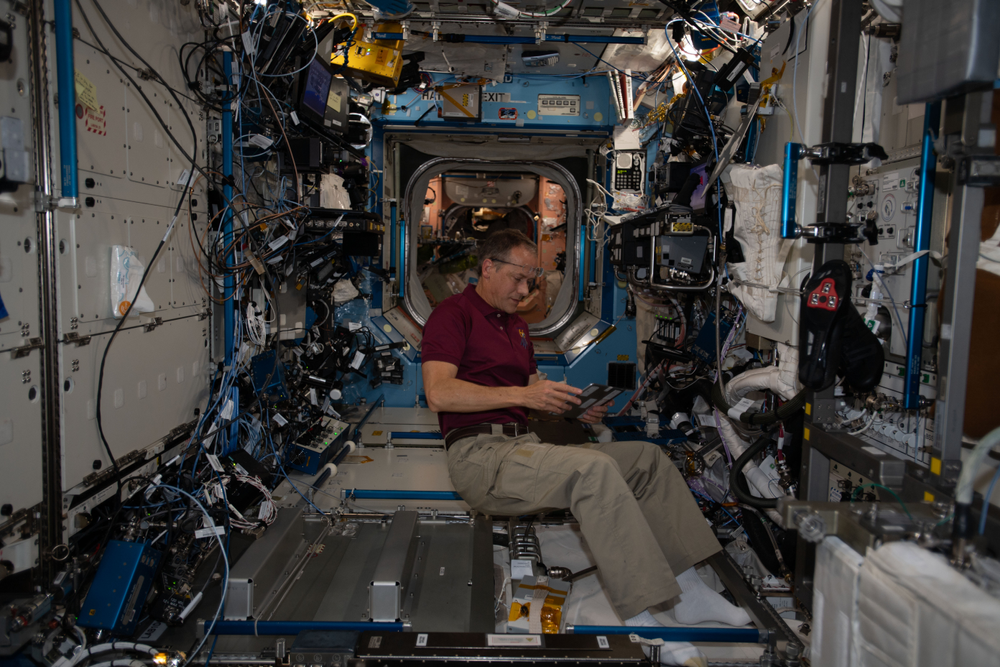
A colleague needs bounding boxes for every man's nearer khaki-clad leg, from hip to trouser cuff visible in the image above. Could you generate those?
[448,436,684,619]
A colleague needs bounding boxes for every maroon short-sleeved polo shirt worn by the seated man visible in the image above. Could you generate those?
[420,285,538,435]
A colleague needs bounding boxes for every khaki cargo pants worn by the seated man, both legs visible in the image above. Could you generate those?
[448,434,722,620]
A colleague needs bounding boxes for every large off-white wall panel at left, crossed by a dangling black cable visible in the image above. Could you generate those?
[49,0,210,489]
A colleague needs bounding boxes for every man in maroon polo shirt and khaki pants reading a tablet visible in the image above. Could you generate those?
[421,230,750,625]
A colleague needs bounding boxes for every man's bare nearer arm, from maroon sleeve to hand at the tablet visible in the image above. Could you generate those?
[422,361,580,412]
